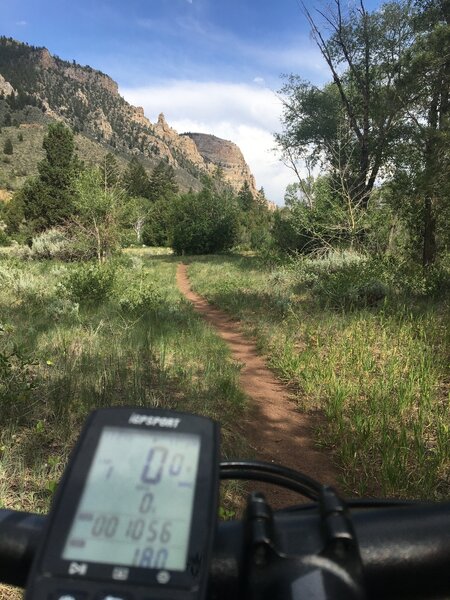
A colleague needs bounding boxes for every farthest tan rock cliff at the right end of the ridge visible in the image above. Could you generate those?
[183,133,256,194]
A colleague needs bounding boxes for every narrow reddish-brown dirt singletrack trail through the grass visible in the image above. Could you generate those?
[177,264,336,508]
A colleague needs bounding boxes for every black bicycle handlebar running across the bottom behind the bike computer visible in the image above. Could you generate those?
[0,503,450,600]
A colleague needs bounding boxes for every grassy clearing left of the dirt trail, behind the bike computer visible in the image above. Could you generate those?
[0,252,244,511]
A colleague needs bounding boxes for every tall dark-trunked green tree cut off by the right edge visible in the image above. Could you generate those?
[394,0,450,266]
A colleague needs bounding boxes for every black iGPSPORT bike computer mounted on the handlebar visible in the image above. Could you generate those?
[25,408,219,600]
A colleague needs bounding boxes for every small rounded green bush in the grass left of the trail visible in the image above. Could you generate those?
[61,263,115,305]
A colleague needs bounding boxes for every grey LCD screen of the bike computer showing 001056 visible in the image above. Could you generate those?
[62,427,200,571]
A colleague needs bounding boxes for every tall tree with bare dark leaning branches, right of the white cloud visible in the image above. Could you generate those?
[277,0,413,208]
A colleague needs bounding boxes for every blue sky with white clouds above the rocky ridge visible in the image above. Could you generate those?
[0,0,384,205]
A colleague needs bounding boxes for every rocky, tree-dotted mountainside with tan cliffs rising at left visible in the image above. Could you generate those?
[0,37,256,191]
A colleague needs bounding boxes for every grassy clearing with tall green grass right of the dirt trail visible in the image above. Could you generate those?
[189,256,450,499]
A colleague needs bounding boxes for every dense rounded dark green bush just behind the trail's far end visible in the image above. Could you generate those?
[171,188,238,254]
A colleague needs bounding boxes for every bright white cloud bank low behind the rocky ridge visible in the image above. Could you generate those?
[121,81,293,205]
